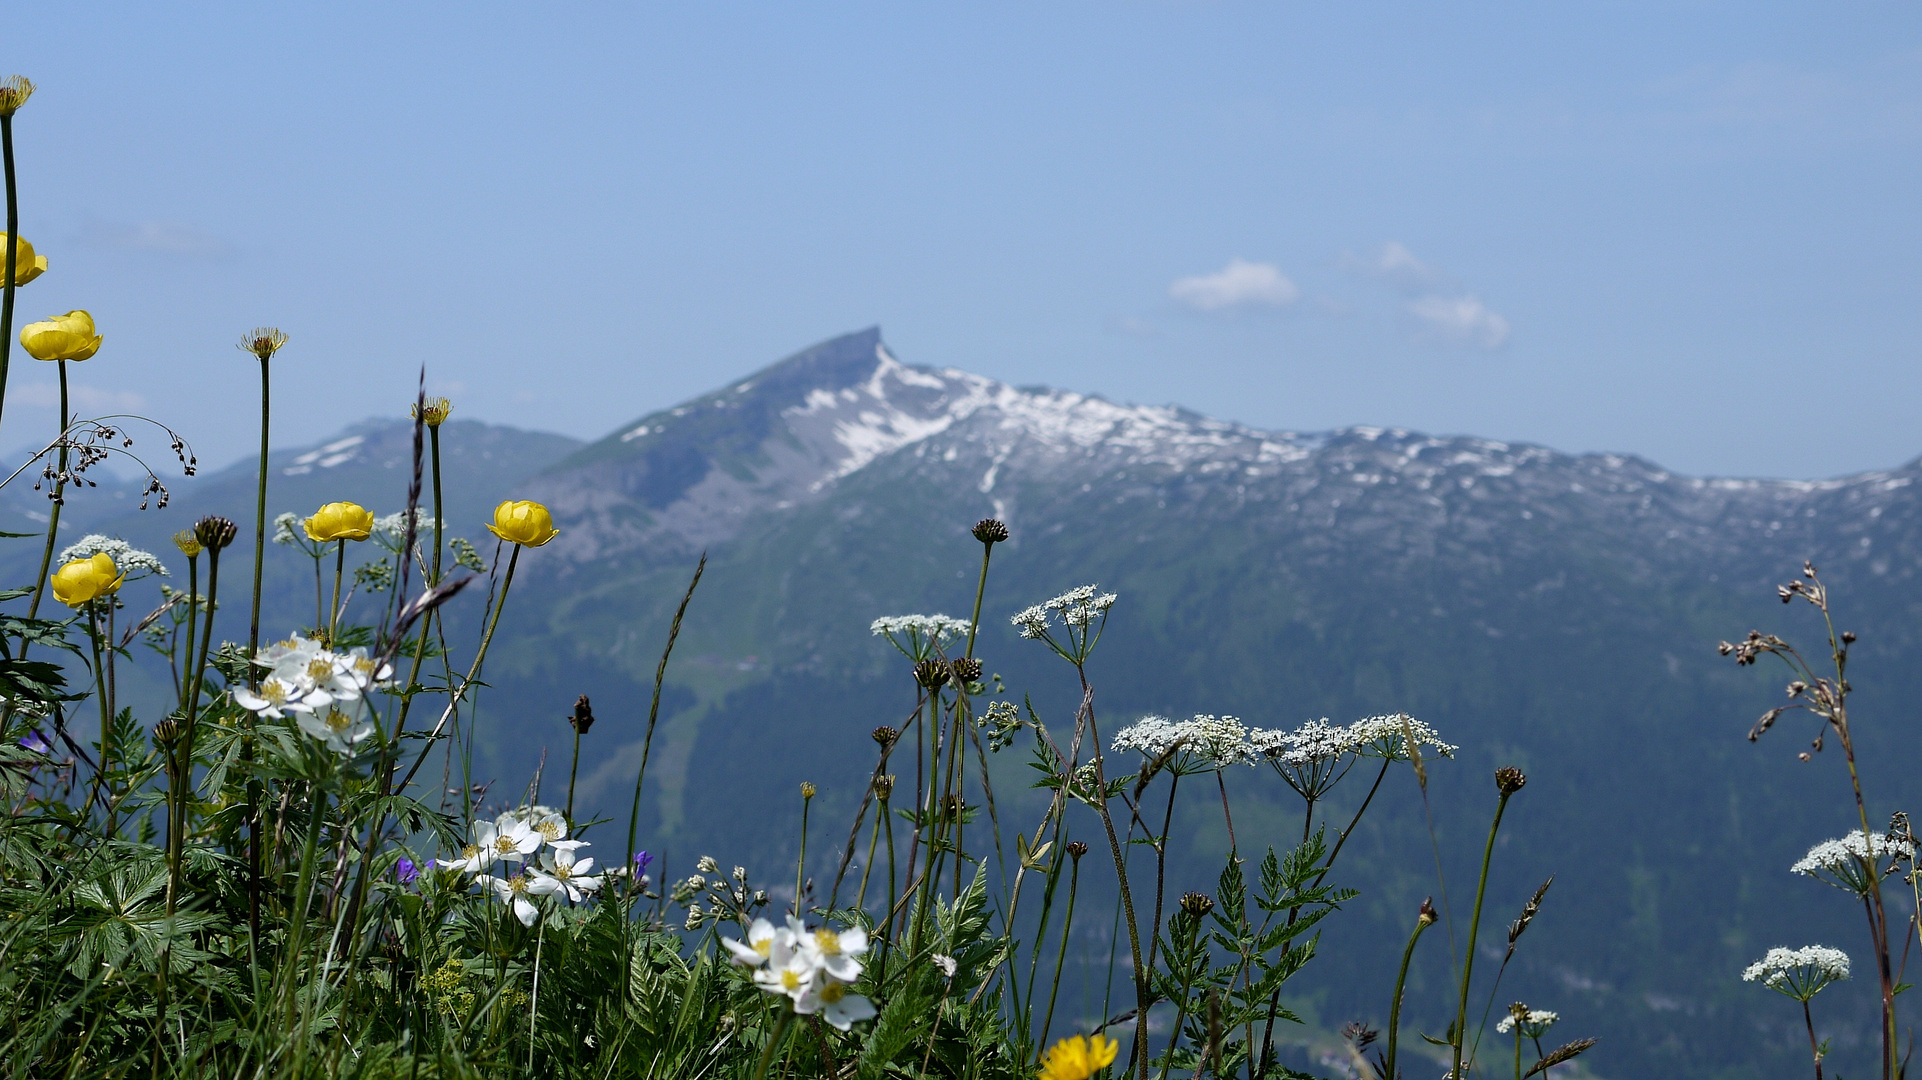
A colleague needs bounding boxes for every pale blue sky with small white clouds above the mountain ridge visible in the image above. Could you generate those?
[0,2,1922,477]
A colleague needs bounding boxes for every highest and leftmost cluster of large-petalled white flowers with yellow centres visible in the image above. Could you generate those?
[233,634,394,753]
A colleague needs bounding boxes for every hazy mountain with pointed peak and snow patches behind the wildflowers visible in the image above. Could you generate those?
[29,331,1922,1078]
